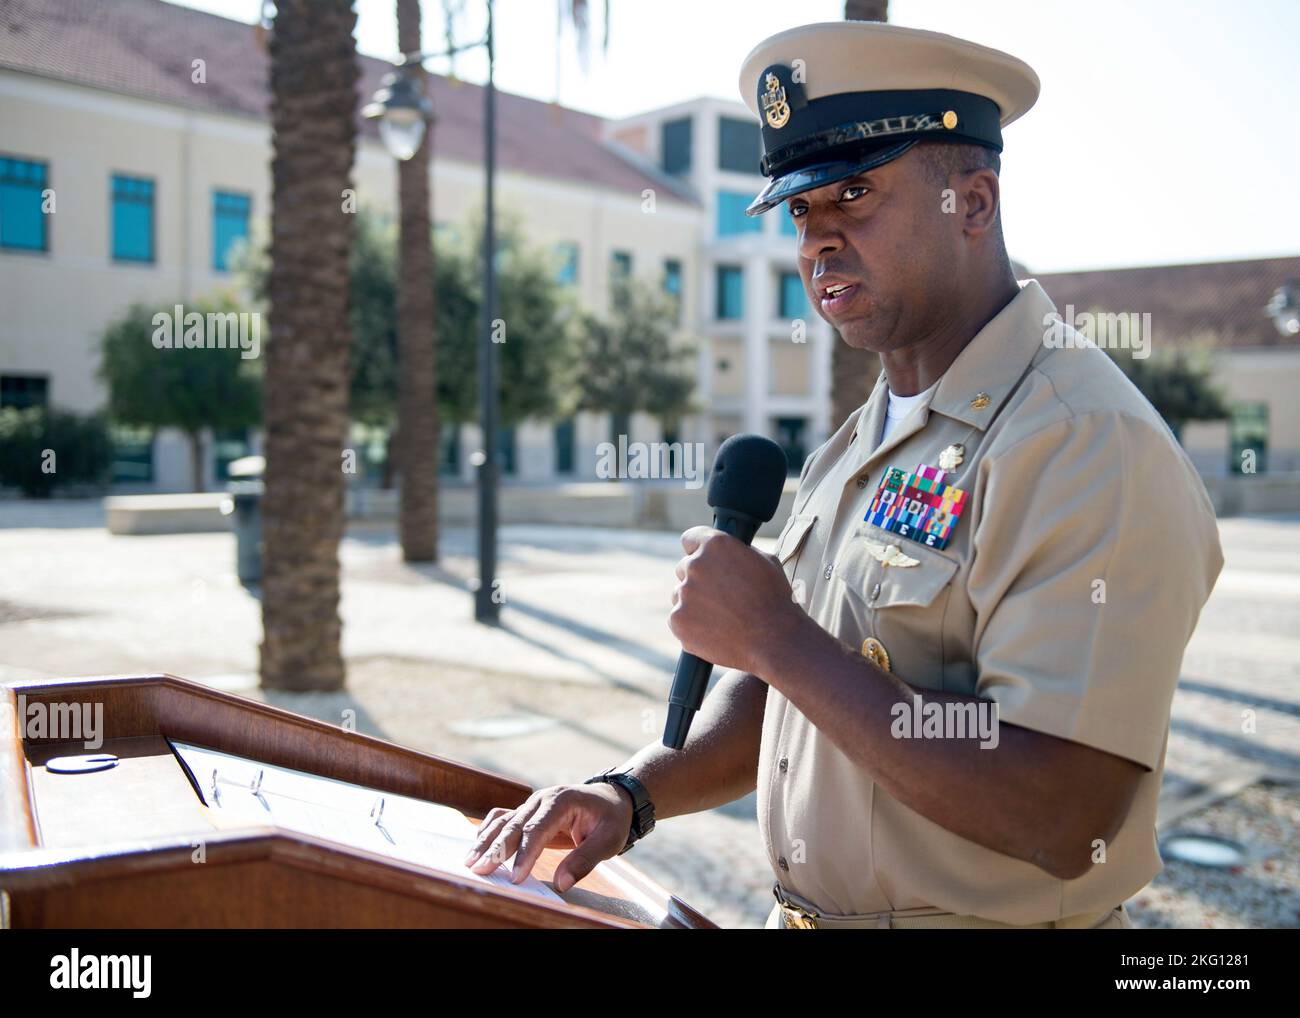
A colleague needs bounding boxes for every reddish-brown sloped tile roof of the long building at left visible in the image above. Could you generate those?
[0,0,694,203]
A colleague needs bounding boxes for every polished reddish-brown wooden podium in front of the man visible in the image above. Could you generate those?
[0,675,714,928]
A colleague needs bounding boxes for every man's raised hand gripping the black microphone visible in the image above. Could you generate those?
[668,527,806,677]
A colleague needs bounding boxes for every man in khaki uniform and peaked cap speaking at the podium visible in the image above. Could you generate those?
[469,23,1223,928]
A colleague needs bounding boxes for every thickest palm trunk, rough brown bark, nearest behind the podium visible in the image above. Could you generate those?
[261,0,359,689]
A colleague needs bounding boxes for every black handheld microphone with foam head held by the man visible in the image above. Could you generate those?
[663,434,788,749]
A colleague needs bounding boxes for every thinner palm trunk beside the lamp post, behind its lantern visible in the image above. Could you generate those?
[398,0,438,562]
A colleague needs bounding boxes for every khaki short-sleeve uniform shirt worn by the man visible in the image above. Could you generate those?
[757,280,1223,924]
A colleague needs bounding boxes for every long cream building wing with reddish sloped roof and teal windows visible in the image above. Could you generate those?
[0,0,706,490]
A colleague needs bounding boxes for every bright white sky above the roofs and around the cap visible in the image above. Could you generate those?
[178,0,1300,272]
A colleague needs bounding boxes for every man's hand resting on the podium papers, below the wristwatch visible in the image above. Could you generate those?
[465,781,632,893]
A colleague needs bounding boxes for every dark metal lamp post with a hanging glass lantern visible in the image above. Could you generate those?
[361,0,501,625]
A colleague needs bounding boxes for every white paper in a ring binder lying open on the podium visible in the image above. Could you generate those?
[169,740,562,901]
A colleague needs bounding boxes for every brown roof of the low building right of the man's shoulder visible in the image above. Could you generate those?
[1035,257,1300,350]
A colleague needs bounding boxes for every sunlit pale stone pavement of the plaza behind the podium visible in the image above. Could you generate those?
[0,502,1300,926]
